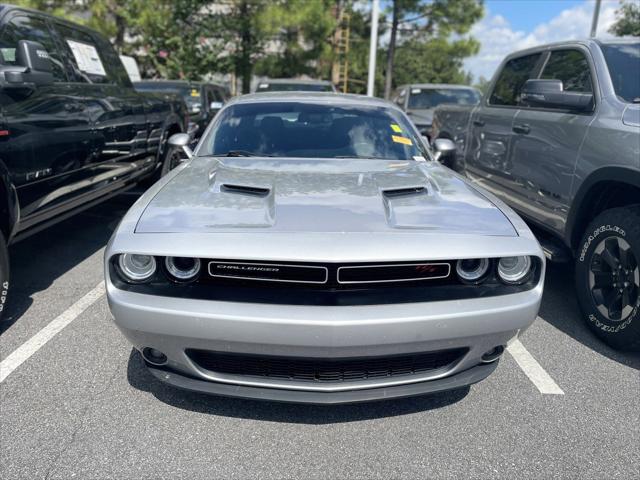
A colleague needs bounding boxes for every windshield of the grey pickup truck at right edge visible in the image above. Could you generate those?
[602,43,640,103]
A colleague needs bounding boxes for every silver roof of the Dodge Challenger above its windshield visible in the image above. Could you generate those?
[227,92,399,110]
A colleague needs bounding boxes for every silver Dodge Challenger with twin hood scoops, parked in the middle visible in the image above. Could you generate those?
[105,93,545,404]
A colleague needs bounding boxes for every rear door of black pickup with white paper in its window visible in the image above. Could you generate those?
[55,22,153,188]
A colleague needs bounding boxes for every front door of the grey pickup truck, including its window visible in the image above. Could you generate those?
[510,47,594,231]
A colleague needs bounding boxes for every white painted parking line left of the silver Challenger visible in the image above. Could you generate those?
[0,282,105,383]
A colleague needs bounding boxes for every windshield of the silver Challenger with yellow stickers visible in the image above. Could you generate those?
[197,101,427,160]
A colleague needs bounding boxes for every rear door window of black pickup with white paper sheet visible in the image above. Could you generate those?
[55,23,130,86]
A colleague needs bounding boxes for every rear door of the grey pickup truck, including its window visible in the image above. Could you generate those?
[465,53,542,205]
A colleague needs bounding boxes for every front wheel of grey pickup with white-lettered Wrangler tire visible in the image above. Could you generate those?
[576,207,640,351]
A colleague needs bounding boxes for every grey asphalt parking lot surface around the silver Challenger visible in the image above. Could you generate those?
[0,192,640,480]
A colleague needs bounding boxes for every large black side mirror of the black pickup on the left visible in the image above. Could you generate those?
[0,40,53,87]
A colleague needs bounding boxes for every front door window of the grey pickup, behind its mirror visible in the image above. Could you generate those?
[540,50,593,93]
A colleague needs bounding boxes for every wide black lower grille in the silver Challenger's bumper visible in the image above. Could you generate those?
[187,348,467,383]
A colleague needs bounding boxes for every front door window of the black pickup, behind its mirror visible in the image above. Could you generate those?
[0,15,67,82]
